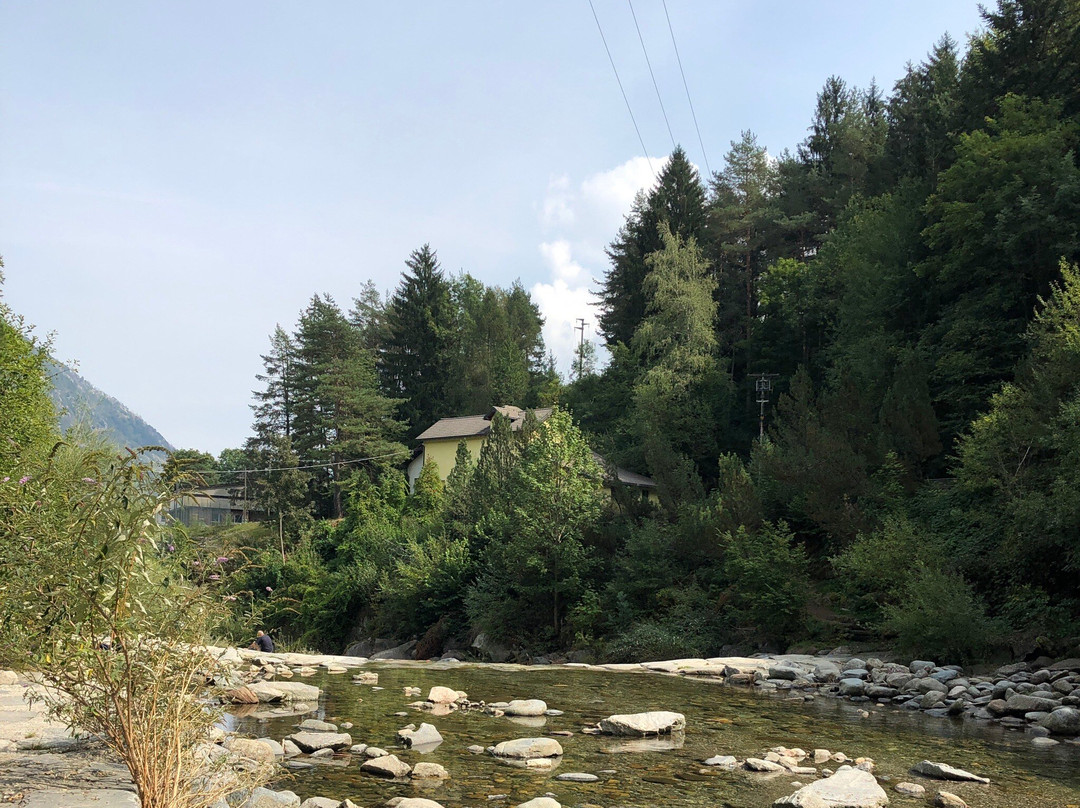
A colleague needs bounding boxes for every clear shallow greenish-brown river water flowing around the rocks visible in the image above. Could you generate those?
[235,663,1080,808]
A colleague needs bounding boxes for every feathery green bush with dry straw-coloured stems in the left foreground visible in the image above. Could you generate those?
[0,444,269,808]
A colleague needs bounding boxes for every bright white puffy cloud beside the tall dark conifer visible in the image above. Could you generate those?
[531,157,667,375]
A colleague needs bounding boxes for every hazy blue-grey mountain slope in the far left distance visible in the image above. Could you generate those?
[50,362,173,450]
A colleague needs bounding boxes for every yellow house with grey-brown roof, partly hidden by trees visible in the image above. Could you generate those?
[407,406,659,502]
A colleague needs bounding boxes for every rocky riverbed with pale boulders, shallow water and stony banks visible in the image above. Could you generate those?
[6,649,1080,808]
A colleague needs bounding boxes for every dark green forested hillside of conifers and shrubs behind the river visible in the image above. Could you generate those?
[177,0,1080,660]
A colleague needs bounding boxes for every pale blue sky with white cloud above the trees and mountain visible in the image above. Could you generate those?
[0,0,980,454]
